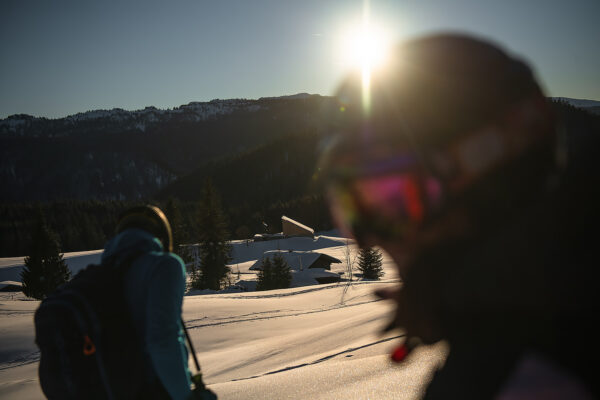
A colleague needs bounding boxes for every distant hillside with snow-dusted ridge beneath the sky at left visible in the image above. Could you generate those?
[0,95,334,202]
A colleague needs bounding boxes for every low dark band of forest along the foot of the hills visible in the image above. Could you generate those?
[0,195,332,257]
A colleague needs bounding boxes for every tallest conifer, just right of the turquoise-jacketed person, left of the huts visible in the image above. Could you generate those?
[192,180,231,290]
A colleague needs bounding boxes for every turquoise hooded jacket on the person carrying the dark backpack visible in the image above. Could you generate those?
[102,229,191,400]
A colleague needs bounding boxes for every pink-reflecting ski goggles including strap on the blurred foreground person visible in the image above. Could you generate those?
[329,99,546,244]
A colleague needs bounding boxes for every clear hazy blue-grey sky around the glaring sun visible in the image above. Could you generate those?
[0,0,600,118]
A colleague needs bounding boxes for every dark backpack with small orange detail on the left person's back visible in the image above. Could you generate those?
[35,254,168,400]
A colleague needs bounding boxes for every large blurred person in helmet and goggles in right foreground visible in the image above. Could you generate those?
[323,34,600,399]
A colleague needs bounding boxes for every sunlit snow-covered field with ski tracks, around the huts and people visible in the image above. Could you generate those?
[0,236,446,399]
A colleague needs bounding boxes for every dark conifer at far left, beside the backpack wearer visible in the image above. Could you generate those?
[21,210,71,300]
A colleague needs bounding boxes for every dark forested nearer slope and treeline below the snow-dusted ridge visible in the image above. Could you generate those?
[0,133,332,257]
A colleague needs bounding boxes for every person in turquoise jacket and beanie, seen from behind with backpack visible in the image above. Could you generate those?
[35,205,216,399]
